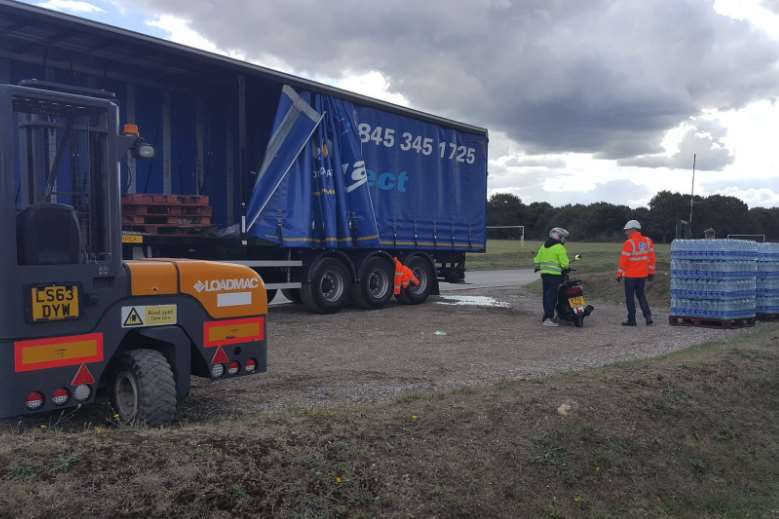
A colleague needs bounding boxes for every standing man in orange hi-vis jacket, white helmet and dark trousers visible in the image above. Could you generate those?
[617,220,655,326]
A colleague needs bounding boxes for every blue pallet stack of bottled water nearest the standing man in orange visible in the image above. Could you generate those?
[669,240,758,329]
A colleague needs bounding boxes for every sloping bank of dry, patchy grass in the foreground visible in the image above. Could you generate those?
[0,324,779,519]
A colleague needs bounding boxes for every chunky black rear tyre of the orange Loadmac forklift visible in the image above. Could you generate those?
[109,349,176,427]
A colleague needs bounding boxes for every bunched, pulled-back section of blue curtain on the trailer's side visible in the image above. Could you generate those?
[247,86,379,248]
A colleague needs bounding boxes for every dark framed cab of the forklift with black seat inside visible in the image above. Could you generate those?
[0,81,136,338]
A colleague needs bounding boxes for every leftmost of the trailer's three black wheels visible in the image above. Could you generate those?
[300,257,351,314]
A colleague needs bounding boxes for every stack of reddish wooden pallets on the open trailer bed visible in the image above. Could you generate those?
[122,193,213,236]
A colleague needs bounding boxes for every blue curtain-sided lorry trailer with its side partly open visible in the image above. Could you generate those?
[0,0,488,313]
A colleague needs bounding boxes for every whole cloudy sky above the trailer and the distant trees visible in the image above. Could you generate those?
[28,0,779,206]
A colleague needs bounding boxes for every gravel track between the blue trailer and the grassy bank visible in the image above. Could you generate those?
[181,288,744,420]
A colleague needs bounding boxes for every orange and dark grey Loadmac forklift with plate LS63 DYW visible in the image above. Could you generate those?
[0,80,267,426]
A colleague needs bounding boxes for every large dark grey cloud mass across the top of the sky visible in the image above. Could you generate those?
[139,0,779,158]
